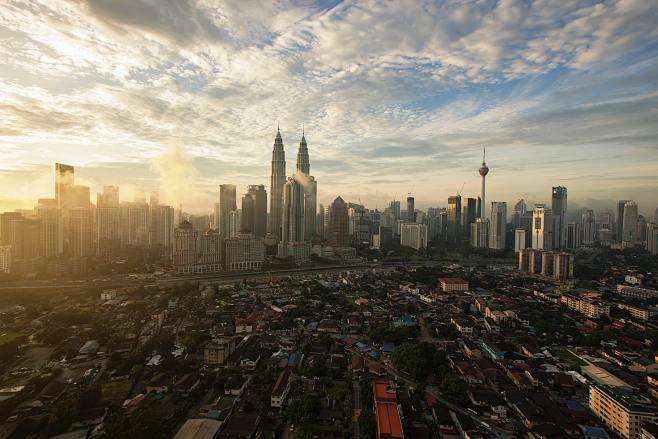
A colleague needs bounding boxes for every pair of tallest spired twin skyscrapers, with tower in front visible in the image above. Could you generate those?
[268,128,317,251]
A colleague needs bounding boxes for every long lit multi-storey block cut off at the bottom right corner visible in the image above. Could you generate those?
[589,384,658,439]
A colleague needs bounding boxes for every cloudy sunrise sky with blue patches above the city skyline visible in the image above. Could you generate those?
[0,0,658,215]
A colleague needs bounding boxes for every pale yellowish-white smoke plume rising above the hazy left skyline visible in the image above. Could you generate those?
[152,145,198,207]
